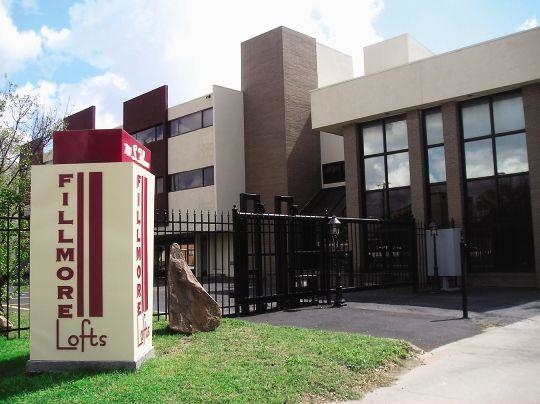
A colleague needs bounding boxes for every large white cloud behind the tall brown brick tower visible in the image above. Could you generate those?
[0,0,383,127]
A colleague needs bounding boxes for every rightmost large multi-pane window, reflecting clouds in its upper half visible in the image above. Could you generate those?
[461,92,534,272]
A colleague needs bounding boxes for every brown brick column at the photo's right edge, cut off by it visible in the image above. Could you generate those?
[522,83,540,288]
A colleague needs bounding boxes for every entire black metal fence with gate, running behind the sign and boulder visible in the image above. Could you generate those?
[0,209,427,337]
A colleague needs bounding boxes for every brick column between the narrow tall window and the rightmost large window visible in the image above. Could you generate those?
[441,102,465,227]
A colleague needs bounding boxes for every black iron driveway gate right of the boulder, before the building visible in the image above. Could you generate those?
[233,200,418,314]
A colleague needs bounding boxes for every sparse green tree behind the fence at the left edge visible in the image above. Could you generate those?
[0,83,63,314]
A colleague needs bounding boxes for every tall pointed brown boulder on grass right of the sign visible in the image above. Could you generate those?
[167,243,221,334]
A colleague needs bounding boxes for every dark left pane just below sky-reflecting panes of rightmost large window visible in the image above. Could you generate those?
[467,178,497,220]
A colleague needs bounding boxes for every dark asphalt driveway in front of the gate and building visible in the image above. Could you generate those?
[244,288,540,351]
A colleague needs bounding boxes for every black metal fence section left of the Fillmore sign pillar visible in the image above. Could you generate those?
[0,211,30,338]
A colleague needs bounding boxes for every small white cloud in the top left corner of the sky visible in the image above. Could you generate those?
[0,2,41,76]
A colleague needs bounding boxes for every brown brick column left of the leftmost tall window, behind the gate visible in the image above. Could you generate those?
[343,124,364,217]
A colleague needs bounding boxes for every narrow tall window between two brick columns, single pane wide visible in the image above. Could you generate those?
[423,108,449,227]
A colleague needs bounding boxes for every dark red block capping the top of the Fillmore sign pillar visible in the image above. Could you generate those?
[53,129,151,171]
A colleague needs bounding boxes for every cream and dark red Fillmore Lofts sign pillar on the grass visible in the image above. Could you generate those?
[27,129,154,372]
